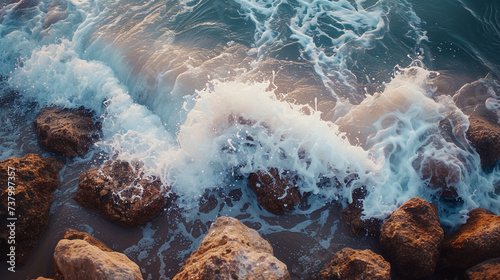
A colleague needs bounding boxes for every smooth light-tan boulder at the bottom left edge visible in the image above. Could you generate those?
[53,229,143,280]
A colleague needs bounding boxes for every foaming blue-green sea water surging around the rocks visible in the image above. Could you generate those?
[0,0,500,279]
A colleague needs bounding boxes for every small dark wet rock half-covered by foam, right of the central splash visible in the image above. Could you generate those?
[341,188,382,236]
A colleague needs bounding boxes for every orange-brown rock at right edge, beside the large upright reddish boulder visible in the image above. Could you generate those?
[441,208,500,268]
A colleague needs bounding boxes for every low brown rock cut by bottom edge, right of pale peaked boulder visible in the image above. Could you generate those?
[316,248,391,280]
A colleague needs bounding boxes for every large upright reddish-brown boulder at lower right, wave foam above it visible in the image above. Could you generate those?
[379,197,444,279]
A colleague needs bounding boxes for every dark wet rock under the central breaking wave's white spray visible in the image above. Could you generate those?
[248,168,301,215]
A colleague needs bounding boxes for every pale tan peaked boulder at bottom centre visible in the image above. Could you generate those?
[173,217,290,280]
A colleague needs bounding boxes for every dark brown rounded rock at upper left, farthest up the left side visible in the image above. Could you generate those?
[34,106,100,158]
